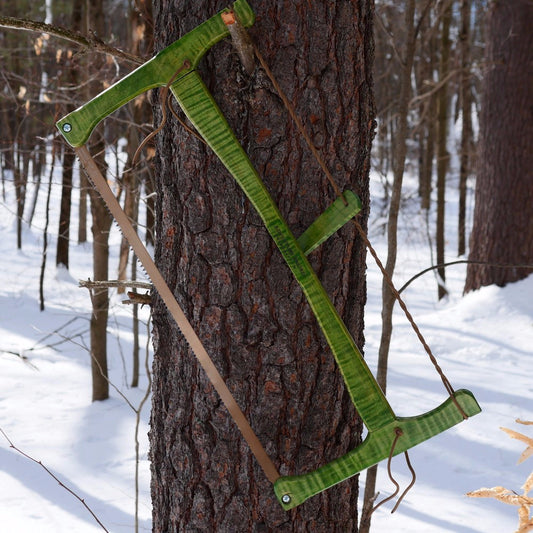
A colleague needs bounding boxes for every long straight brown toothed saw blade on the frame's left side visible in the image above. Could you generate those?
[75,145,280,483]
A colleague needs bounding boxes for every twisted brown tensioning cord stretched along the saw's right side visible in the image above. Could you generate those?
[247,38,468,420]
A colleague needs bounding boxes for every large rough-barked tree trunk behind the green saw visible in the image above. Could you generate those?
[150,0,374,533]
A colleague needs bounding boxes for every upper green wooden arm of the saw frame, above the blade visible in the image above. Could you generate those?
[57,0,255,148]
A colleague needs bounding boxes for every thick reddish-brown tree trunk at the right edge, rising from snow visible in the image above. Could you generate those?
[465,0,533,292]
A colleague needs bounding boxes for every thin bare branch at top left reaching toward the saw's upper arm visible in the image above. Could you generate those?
[0,15,145,65]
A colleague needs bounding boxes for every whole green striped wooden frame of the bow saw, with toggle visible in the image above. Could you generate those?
[57,0,481,509]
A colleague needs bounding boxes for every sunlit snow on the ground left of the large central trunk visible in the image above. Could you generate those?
[0,171,151,533]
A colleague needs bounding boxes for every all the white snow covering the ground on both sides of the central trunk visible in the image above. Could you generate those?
[0,164,533,533]
